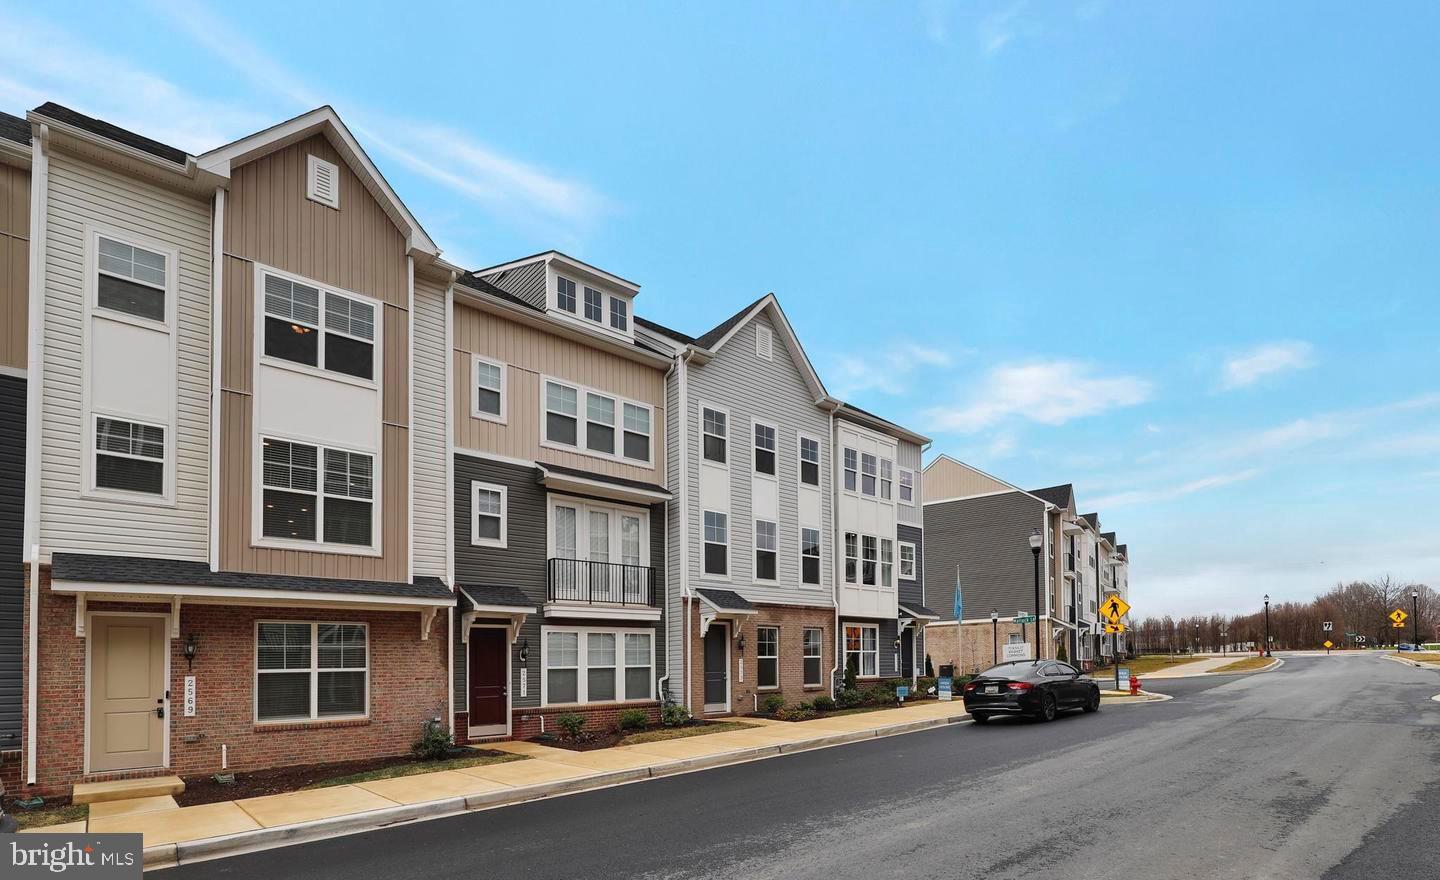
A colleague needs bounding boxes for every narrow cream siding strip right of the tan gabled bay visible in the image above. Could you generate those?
[412,279,449,578]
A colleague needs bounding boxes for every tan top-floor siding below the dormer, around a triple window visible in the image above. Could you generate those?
[451,305,665,484]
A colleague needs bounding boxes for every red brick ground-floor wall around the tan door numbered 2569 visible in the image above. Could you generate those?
[26,569,448,796]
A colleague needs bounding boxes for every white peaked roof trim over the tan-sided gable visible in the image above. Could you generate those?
[197,104,441,256]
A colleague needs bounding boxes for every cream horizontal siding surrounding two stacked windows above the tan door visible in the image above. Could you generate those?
[40,151,210,560]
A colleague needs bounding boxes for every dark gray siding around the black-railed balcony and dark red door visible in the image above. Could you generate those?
[454,454,668,711]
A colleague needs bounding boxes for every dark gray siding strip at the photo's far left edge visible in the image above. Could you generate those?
[0,376,26,750]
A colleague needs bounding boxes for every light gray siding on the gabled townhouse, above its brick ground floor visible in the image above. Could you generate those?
[684,313,834,606]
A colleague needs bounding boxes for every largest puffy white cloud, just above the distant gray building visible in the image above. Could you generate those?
[926,360,1155,434]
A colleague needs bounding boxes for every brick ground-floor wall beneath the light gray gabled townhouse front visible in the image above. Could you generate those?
[677,603,835,717]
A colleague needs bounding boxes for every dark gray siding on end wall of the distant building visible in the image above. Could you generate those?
[924,493,1044,619]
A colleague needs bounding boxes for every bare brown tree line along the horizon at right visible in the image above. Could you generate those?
[1130,575,1440,654]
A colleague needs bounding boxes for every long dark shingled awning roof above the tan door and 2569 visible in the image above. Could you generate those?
[50,553,451,599]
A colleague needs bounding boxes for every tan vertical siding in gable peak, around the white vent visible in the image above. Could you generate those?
[225,134,409,308]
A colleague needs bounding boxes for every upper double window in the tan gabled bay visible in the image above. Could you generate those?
[265,272,376,380]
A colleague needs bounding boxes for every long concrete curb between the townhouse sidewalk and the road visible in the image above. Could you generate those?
[144,711,971,870]
